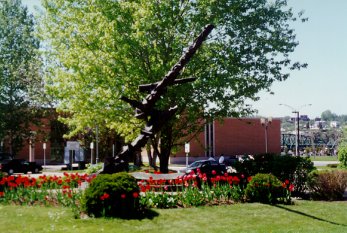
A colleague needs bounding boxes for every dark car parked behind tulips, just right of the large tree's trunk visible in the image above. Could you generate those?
[186,160,227,175]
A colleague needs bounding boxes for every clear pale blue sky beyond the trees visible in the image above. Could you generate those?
[22,0,347,118]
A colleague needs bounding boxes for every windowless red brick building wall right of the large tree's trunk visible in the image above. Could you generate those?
[170,118,281,163]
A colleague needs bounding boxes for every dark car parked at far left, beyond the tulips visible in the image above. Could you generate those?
[0,159,42,175]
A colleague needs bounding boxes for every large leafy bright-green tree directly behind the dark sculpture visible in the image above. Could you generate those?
[40,0,304,171]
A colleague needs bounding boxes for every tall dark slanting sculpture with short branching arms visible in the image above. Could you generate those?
[102,25,214,173]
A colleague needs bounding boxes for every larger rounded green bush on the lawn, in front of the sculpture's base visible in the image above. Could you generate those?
[82,172,140,218]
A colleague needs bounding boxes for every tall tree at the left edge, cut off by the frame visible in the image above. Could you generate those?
[0,0,42,157]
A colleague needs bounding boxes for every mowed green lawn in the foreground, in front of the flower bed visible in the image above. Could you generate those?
[0,201,347,233]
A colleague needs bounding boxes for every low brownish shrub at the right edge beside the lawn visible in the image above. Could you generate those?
[308,170,347,201]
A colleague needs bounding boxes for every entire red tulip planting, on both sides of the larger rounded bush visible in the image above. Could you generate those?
[0,168,293,218]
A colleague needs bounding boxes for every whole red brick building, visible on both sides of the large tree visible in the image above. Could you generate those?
[12,115,281,163]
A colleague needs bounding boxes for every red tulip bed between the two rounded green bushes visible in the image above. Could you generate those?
[138,170,287,208]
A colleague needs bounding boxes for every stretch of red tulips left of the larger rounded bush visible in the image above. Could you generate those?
[0,173,93,207]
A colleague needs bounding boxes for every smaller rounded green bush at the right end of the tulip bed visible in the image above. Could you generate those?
[245,173,291,204]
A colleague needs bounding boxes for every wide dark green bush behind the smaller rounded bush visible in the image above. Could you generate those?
[235,154,315,196]
